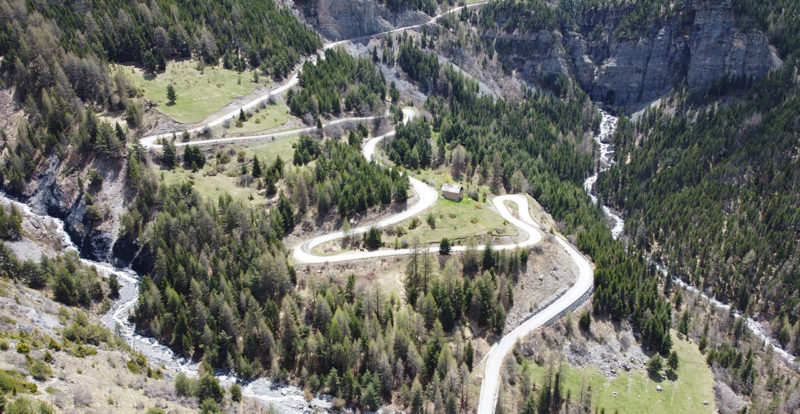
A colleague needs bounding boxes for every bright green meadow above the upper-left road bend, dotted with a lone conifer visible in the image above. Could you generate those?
[114,60,271,123]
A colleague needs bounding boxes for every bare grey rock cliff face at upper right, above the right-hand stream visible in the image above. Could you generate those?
[485,0,782,107]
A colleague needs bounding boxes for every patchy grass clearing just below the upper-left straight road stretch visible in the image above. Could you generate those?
[154,136,298,204]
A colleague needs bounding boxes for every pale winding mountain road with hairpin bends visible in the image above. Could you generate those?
[133,1,593,414]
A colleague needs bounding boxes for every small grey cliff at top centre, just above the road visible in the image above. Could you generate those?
[301,0,430,40]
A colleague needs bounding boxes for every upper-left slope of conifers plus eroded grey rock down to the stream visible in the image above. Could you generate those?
[0,0,321,264]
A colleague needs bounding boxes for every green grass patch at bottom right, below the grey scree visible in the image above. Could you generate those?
[520,331,714,414]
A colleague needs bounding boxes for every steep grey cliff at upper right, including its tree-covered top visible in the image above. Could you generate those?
[480,0,781,107]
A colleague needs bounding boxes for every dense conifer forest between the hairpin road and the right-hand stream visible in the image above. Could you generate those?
[389,35,671,355]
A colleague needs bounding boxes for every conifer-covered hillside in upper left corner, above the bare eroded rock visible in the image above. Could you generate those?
[0,0,321,201]
